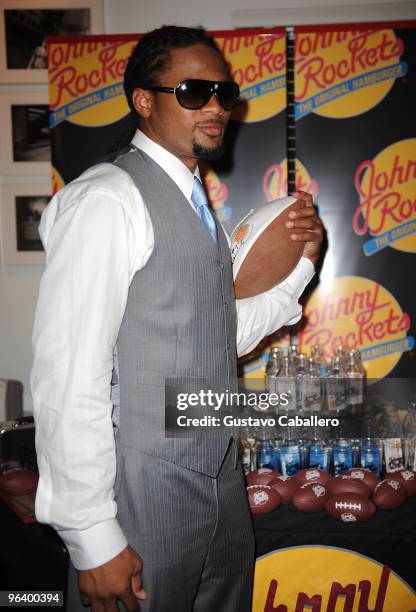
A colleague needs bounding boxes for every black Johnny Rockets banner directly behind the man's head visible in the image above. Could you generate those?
[48,29,287,232]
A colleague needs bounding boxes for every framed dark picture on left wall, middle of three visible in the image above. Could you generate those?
[0,92,51,176]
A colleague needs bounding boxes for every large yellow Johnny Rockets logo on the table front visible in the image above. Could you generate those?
[252,546,416,612]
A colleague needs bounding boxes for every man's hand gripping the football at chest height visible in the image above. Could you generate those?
[286,191,323,266]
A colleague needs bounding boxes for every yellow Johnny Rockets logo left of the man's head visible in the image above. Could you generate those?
[48,40,136,127]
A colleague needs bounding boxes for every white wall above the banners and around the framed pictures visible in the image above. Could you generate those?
[0,0,416,413]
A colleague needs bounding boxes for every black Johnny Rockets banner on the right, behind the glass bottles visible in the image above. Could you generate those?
[247,24,416,379]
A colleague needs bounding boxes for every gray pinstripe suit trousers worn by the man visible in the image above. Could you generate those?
[67,442,254,612]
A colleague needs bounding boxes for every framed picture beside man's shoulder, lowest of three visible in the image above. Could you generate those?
[1,183,51,264]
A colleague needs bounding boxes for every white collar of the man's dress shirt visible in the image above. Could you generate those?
[131,130,201,202]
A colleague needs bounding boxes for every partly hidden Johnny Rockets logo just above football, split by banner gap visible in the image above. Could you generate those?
[263,159,318,202]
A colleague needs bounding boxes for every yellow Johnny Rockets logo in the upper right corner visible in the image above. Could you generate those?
[295,30,407,119]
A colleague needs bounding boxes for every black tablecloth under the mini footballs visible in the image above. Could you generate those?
[0,496,416,604]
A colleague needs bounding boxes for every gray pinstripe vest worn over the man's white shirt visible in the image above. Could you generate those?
[114,149,237,476]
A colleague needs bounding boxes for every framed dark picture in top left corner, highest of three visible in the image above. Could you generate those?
[0,0,104,83]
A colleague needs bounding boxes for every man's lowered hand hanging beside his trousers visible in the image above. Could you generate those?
[78,546,146,612]
